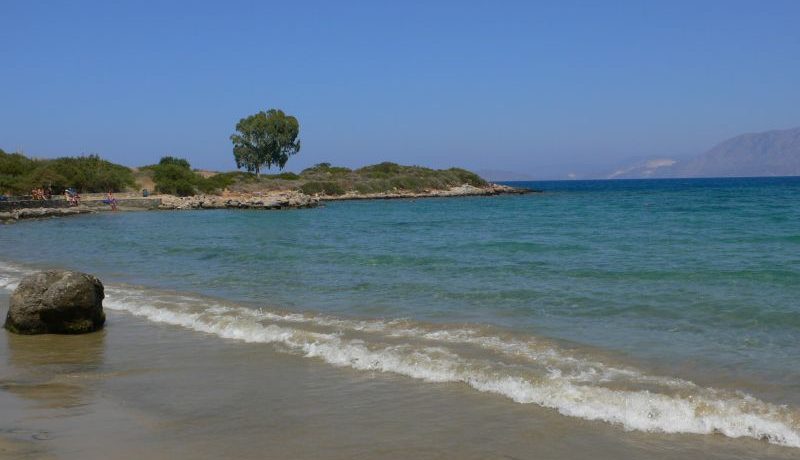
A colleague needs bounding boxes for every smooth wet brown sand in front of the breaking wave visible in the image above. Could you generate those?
[0,295,797,459]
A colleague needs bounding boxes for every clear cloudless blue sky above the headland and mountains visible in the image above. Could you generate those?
[0,0,800,177]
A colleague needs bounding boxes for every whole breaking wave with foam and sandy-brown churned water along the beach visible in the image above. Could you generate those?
[0,265,800,447]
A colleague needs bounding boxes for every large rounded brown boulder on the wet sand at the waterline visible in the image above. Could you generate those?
[5,270,106,334]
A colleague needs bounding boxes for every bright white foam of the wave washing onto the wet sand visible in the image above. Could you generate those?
[106,288,800,447]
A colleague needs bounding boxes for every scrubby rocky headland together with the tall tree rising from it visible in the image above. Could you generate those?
[0,109,529,221]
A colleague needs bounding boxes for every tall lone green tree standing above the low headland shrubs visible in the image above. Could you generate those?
[231,109,300,175]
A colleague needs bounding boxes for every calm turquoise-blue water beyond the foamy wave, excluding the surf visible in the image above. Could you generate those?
[0,178,800,444]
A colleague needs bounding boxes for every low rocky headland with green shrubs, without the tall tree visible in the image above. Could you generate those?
[0,154,534,222]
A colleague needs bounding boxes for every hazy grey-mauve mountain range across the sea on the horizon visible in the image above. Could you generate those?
[604,128,800,179]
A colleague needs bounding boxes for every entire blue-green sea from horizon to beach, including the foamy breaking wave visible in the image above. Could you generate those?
[0,178,800,446]
